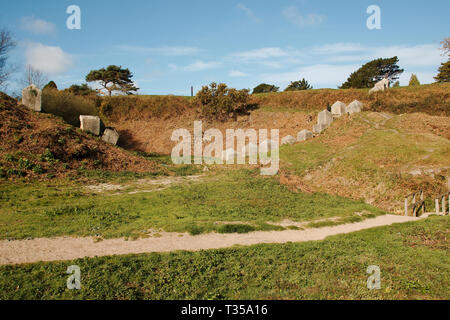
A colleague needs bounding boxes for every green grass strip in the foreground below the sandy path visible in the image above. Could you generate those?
[0,217,450,300]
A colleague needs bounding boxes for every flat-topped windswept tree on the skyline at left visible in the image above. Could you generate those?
[86,65,139,96]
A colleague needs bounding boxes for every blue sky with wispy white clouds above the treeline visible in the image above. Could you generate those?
[0,0,450,95]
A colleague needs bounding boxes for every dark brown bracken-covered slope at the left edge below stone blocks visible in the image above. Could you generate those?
[0,92,160,179]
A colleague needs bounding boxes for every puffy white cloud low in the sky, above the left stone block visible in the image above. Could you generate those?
[25,43,72,74]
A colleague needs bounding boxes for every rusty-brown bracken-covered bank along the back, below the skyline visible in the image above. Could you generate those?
[101,83,450,154]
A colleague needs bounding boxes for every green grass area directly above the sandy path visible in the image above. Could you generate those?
[0,170,384,239]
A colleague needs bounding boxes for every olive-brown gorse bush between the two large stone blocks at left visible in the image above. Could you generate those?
[42,90,98,127]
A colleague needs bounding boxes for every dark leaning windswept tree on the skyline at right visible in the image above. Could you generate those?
[340,57,404,89]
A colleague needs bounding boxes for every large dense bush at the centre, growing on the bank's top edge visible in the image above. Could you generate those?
[196,82,254,121]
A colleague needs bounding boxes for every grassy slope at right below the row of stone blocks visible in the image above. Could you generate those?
[280,112,450,212]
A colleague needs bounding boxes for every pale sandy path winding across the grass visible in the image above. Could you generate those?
[0,215,421,265]
